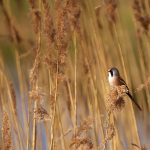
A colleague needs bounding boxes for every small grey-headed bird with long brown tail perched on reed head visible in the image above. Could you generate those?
[108,67,142,111]
